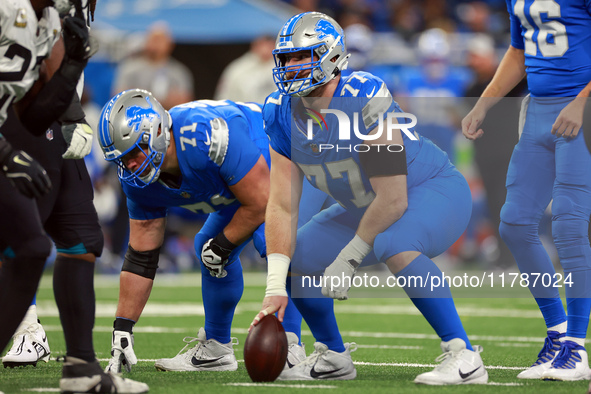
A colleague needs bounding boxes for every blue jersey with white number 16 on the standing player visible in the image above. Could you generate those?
[506,0,591,97]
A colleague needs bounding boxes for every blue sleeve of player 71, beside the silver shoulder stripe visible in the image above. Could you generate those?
[220,116,261,186]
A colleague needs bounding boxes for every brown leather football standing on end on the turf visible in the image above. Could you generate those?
[244,315,287,382]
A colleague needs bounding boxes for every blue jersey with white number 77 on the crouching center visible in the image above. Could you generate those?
[263,72,453,211]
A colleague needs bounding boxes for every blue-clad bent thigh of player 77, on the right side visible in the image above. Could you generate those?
[374,170,472,262]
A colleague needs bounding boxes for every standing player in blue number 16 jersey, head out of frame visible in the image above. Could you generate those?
[462,0,591,380]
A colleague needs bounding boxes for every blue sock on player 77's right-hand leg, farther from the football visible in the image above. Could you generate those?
[396,254,472,350]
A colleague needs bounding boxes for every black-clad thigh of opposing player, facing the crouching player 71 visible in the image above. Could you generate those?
[44,160,104,257]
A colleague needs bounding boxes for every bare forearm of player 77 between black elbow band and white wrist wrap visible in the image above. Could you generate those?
[357,194,408,245]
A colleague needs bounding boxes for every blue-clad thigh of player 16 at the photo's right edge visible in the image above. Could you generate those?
[552,132,591,220]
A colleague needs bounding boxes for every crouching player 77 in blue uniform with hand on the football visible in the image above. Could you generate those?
[253,12,488,385]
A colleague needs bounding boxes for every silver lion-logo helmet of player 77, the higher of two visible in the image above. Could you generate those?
[273,12,351,97]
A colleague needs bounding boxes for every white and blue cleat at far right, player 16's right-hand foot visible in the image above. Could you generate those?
[541,341,591,381]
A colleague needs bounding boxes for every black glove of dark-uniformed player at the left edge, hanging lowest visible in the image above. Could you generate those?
[0,139,51,198]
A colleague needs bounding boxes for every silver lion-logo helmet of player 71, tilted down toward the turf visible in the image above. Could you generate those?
[98,89,172,187]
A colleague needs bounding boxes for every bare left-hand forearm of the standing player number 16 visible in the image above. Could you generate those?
[477,46,525,111]
